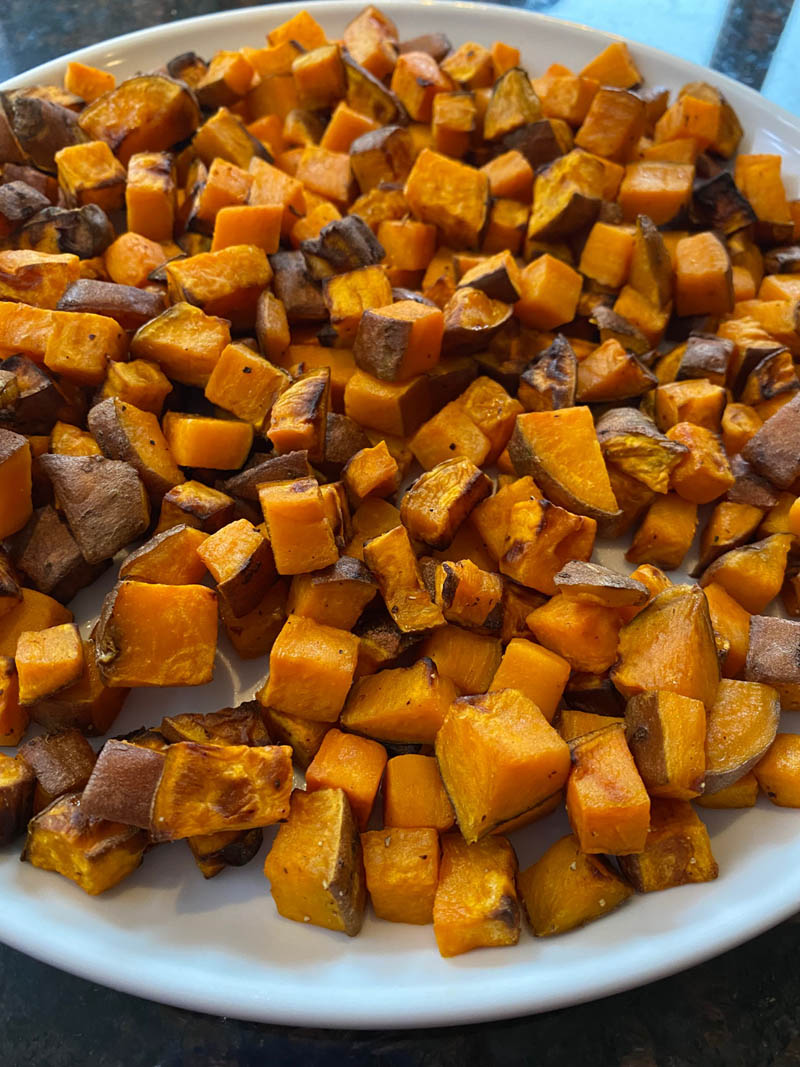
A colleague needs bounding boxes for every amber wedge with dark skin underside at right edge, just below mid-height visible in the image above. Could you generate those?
[700,534,791,615]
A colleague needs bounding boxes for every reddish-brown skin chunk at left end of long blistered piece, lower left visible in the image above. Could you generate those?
[81,738,164,830]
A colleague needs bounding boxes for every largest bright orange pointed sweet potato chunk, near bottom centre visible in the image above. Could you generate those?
[435,689,570,842]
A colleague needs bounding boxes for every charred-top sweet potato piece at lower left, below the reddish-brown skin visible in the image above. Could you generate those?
[22,793,150,895]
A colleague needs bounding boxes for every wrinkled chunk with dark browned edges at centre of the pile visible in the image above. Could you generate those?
[400,459,492,548]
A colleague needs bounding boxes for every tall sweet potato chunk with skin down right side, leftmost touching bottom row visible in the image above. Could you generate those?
[263,789,367,937]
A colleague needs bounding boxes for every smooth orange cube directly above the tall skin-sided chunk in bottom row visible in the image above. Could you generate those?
[305,729,387,830]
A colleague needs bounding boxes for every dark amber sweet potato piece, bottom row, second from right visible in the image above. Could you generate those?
[517,834,633,937]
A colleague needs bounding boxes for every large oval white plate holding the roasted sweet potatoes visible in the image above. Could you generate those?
[0,0,800,1028]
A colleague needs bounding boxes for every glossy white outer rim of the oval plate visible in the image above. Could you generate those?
[0,0,800,1030]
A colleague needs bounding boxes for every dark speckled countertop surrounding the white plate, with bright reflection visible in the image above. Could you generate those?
[0,0,800,1067]
